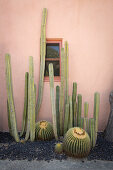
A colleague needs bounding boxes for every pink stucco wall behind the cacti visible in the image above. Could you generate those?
[0,0,113,131]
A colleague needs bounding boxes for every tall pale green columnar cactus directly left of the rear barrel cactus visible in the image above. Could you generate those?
[25,56,36,141]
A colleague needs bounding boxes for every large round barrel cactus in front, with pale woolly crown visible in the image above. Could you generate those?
[63,127,91,158]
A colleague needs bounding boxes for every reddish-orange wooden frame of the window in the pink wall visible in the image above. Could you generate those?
[44,38,62,82]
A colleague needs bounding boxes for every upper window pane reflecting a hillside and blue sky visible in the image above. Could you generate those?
[46,43,59,58]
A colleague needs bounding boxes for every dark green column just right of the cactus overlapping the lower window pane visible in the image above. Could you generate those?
[56,86,60,136]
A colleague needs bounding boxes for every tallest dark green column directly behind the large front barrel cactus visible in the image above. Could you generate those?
[72,82,77,126]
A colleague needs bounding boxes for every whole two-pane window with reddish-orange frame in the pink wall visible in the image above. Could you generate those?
[44,39,61,81]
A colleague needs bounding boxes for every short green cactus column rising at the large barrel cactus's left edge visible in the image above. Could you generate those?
[64,103,69,135]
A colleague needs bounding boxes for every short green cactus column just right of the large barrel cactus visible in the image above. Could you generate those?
[89,118,96,147]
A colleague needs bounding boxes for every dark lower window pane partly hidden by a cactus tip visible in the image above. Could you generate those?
[44,61,60,76]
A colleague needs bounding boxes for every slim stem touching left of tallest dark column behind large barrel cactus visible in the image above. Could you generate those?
[68,96,73,129]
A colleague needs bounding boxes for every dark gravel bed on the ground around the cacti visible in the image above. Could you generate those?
[0,132,113,162]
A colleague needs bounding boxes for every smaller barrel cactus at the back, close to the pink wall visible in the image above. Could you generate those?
[35,120,54,140]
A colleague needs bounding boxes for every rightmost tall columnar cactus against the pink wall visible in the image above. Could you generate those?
[94,93,100,139]
